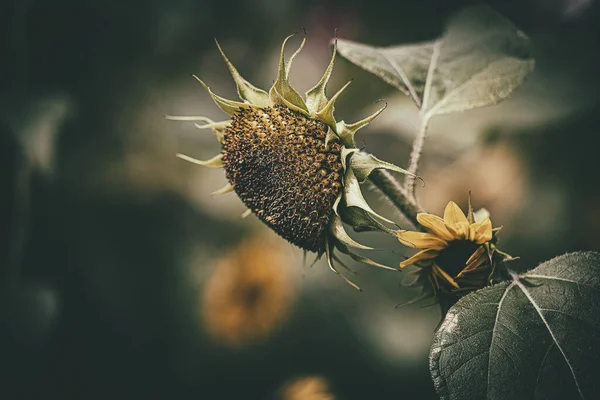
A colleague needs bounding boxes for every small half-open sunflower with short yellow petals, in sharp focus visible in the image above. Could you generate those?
[397,201,495,293]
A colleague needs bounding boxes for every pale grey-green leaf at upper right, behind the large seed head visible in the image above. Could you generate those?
[338,6,534,118]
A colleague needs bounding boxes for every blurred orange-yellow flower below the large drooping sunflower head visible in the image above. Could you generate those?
[201,238,295,347]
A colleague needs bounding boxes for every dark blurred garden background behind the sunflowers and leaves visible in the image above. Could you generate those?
[0,0,600,400]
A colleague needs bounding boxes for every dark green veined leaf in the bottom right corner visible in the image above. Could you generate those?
[430,252,600,400]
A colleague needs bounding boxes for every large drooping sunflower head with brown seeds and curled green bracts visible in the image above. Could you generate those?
[167,35,408,287]
